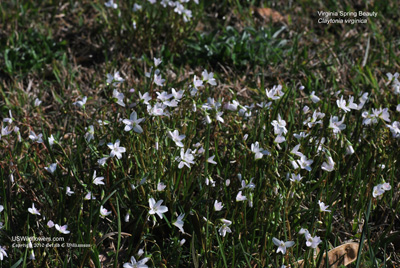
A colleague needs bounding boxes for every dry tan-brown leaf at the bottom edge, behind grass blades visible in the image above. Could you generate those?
[293,243,358,268]
